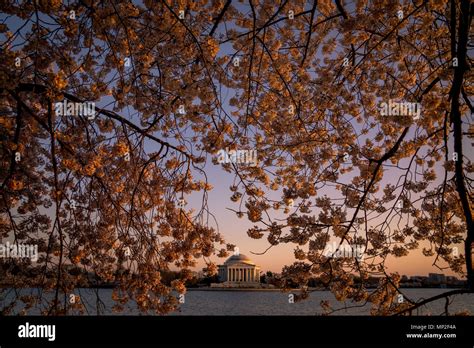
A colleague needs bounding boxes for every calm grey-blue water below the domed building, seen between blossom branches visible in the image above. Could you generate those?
[0,289,474,315]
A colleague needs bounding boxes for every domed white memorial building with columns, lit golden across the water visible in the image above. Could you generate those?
[215,254,260,287]
